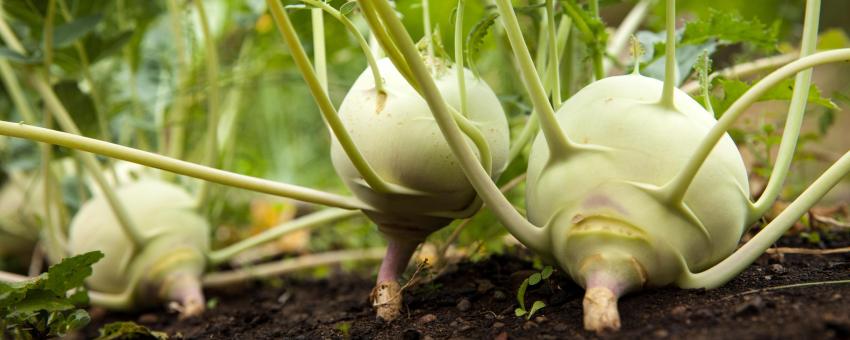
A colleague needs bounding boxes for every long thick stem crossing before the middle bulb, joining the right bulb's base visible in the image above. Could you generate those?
[360,0,551,250]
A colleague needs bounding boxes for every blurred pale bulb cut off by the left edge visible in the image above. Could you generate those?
[0,173,44,262]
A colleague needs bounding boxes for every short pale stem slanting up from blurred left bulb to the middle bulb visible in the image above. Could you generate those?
[207,209,360,265]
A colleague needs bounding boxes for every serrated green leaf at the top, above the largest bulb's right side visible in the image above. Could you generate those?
[682,10,779,51]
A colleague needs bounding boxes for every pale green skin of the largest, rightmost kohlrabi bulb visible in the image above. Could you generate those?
[527,75,750,286]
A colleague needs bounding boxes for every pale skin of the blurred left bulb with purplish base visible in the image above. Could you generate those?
[69,179,210,305]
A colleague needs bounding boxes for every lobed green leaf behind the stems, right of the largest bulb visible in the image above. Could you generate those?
[711,77,838,117]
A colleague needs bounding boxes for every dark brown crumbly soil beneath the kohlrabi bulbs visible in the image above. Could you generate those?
[85,235,850,340]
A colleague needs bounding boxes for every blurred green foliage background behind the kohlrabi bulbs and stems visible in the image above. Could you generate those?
[0,0,850,274]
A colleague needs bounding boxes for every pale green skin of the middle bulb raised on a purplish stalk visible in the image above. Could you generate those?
[331,59,510,238]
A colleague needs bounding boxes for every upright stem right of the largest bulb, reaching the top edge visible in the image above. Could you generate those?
[750,0,820,221]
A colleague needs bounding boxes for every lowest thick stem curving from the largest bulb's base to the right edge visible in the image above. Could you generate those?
[676,150,850,288]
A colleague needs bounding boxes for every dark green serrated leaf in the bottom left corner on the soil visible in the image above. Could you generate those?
[0,251,103,339]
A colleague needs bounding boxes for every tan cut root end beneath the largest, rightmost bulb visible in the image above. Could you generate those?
[582,287,620,334]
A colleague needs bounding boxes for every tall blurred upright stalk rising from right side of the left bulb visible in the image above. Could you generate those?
[194,0,221,207]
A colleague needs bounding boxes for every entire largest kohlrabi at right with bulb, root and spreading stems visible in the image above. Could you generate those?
[361,0,850,331]
